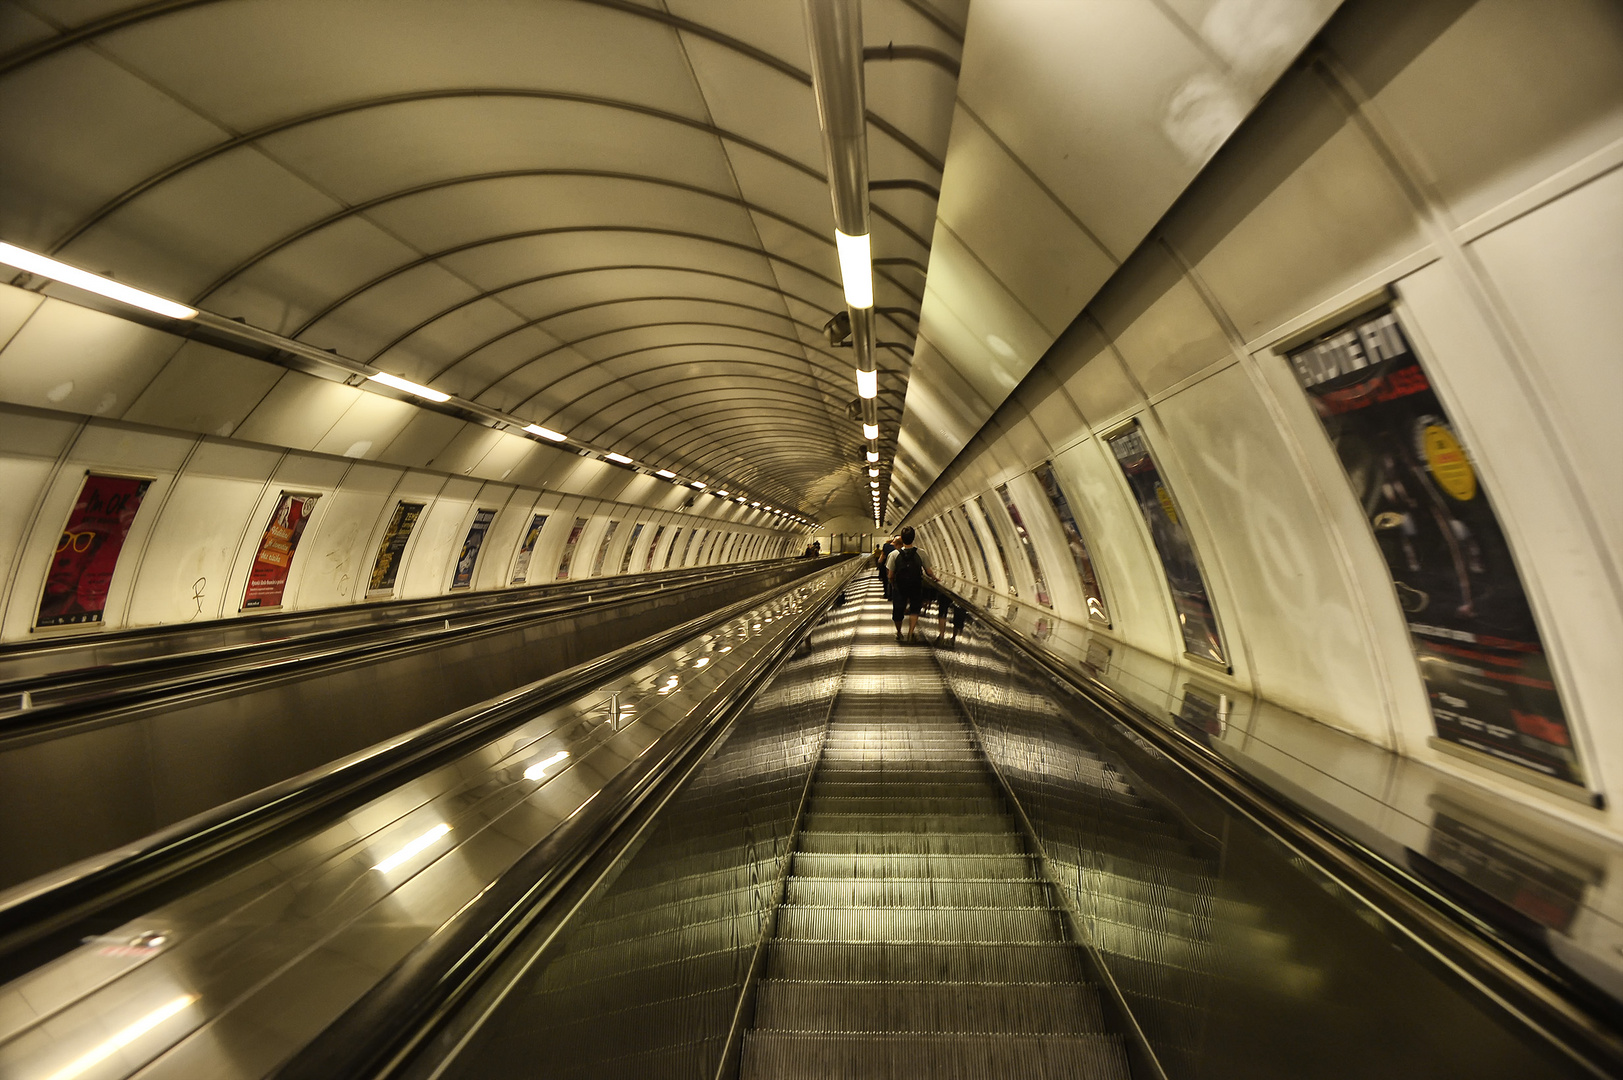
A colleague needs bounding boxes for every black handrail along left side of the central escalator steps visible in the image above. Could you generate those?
[273,559,868,1080]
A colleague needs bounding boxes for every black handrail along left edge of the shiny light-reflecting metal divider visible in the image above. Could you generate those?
[0,555,856,957]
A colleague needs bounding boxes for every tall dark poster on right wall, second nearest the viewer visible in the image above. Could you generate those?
[1107,421,1229,664]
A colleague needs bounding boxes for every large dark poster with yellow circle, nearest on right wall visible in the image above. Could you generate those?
[1287,307,1584,784]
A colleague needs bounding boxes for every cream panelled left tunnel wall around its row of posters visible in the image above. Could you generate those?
[0,357,799,640]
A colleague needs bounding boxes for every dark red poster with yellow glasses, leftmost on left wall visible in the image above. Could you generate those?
[34,473,153,629]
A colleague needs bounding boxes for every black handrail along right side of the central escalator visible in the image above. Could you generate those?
[936,583,1623,1077]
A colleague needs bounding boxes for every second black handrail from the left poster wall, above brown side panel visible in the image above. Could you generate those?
[0,562,837,741]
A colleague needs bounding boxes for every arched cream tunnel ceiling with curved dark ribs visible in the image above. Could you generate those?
[0,0,967,518]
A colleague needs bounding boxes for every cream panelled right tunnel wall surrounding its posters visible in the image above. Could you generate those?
[907,0,1623,832]
